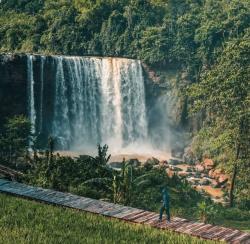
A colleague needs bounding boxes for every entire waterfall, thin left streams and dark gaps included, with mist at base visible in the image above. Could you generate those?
[27,55,176,155]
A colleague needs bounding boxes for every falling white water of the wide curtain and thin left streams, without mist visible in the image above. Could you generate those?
[28,56,148,150]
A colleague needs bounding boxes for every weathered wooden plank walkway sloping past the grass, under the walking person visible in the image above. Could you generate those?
[0,179,250,244]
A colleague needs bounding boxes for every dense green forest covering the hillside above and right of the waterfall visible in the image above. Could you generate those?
[0,0,250,223]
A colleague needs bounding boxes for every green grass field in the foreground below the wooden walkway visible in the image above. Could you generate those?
[0,194,219,244]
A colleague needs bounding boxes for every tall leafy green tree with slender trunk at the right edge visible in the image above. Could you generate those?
[190,35,250,206]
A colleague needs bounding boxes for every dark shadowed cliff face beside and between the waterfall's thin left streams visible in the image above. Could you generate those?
[0,54,54,137]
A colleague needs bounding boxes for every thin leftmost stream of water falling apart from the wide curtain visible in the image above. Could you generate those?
[27,55,36,146]
